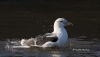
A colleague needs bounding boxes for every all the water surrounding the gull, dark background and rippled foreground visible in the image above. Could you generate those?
[0,1,100,57]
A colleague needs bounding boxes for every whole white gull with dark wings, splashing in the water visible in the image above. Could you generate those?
[21,18,73,48]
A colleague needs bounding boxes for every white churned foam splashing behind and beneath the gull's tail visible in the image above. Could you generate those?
[5,39,42,50]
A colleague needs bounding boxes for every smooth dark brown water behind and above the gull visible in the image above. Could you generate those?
[0,1,100,40]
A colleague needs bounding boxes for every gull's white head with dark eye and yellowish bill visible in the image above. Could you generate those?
[54,18,73,27]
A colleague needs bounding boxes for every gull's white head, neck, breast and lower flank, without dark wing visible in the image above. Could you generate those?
[42,18,73,48]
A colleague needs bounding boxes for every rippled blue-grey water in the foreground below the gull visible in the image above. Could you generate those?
[0,38,100,57]
